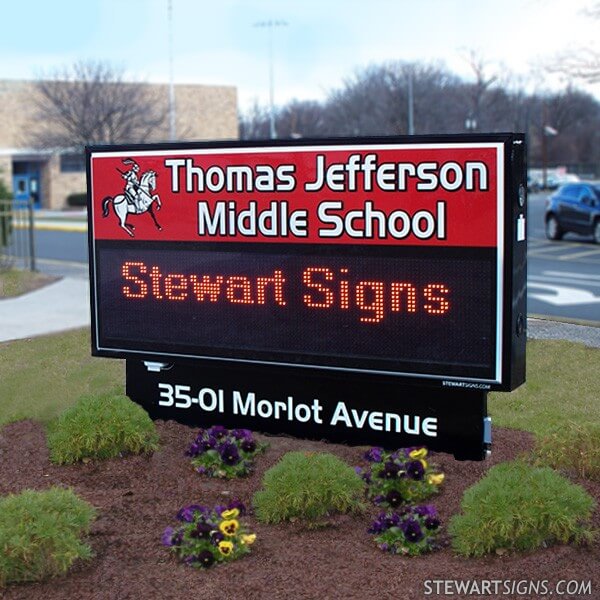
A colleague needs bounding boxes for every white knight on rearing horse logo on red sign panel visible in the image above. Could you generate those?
[102,158,162,237]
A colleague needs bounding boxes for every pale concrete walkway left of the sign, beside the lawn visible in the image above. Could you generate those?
[0,277,90,342]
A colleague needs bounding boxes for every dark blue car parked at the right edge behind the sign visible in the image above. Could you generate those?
[546,183,600,244]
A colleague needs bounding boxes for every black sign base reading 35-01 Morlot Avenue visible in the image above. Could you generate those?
[126,360,490,460]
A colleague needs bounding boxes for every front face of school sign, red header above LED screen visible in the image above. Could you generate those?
[88,140,528,388]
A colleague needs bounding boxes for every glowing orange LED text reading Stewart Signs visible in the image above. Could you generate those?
[121,261,451,323]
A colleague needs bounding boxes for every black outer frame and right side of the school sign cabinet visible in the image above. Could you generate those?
[86,133,526,391]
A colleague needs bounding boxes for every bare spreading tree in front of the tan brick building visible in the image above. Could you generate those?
[32,62,166,149]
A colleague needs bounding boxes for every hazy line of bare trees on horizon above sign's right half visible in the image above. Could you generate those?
[240,54,600,174]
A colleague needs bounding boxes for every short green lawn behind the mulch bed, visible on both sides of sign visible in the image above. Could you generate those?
[0,330,600,434]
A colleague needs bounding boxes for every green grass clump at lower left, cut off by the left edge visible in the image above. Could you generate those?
[0,488,96,588]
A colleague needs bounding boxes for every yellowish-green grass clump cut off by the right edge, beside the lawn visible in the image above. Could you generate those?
[534,421,600,481]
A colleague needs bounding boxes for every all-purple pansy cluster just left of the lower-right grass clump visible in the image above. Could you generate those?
[369,505,441,556]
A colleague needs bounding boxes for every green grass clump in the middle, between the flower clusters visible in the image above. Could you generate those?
[253,452,365,527]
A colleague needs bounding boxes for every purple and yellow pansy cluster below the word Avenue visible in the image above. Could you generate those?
[356,447,444,508]
